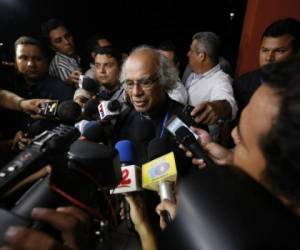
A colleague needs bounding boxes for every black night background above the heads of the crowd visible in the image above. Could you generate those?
[0,0,246,73]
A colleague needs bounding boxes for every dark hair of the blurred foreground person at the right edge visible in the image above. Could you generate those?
[261,57,300,206]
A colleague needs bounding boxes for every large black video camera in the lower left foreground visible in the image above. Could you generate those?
[0,125,121,245]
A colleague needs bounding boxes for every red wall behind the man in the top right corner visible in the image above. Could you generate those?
[236,0,300,76]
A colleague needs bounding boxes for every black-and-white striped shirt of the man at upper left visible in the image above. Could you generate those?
[49,52,81,81]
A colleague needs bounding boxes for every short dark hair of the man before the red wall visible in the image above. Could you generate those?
[262,18,300,53]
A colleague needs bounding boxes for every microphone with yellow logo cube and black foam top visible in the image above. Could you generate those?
[142,138,177,224]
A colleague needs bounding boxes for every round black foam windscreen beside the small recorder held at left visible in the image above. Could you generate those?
[57,100,81,124]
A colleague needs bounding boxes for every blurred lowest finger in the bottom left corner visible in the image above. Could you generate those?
[4,227,63,250]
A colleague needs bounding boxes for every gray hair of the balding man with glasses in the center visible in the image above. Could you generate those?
[120,45,178,91]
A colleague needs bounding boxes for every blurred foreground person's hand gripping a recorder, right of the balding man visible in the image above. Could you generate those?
[179,127,232,168]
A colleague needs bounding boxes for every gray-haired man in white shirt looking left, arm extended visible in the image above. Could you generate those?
[186,32,237,140]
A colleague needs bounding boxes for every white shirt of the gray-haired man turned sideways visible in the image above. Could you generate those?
[186,64,237,119]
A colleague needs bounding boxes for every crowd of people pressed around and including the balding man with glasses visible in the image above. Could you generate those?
[0,18,300,250]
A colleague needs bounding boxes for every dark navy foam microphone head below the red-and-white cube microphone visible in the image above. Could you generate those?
[79,121,107,144]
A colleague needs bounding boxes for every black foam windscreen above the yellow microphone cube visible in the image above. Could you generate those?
[148,137,172,161]
